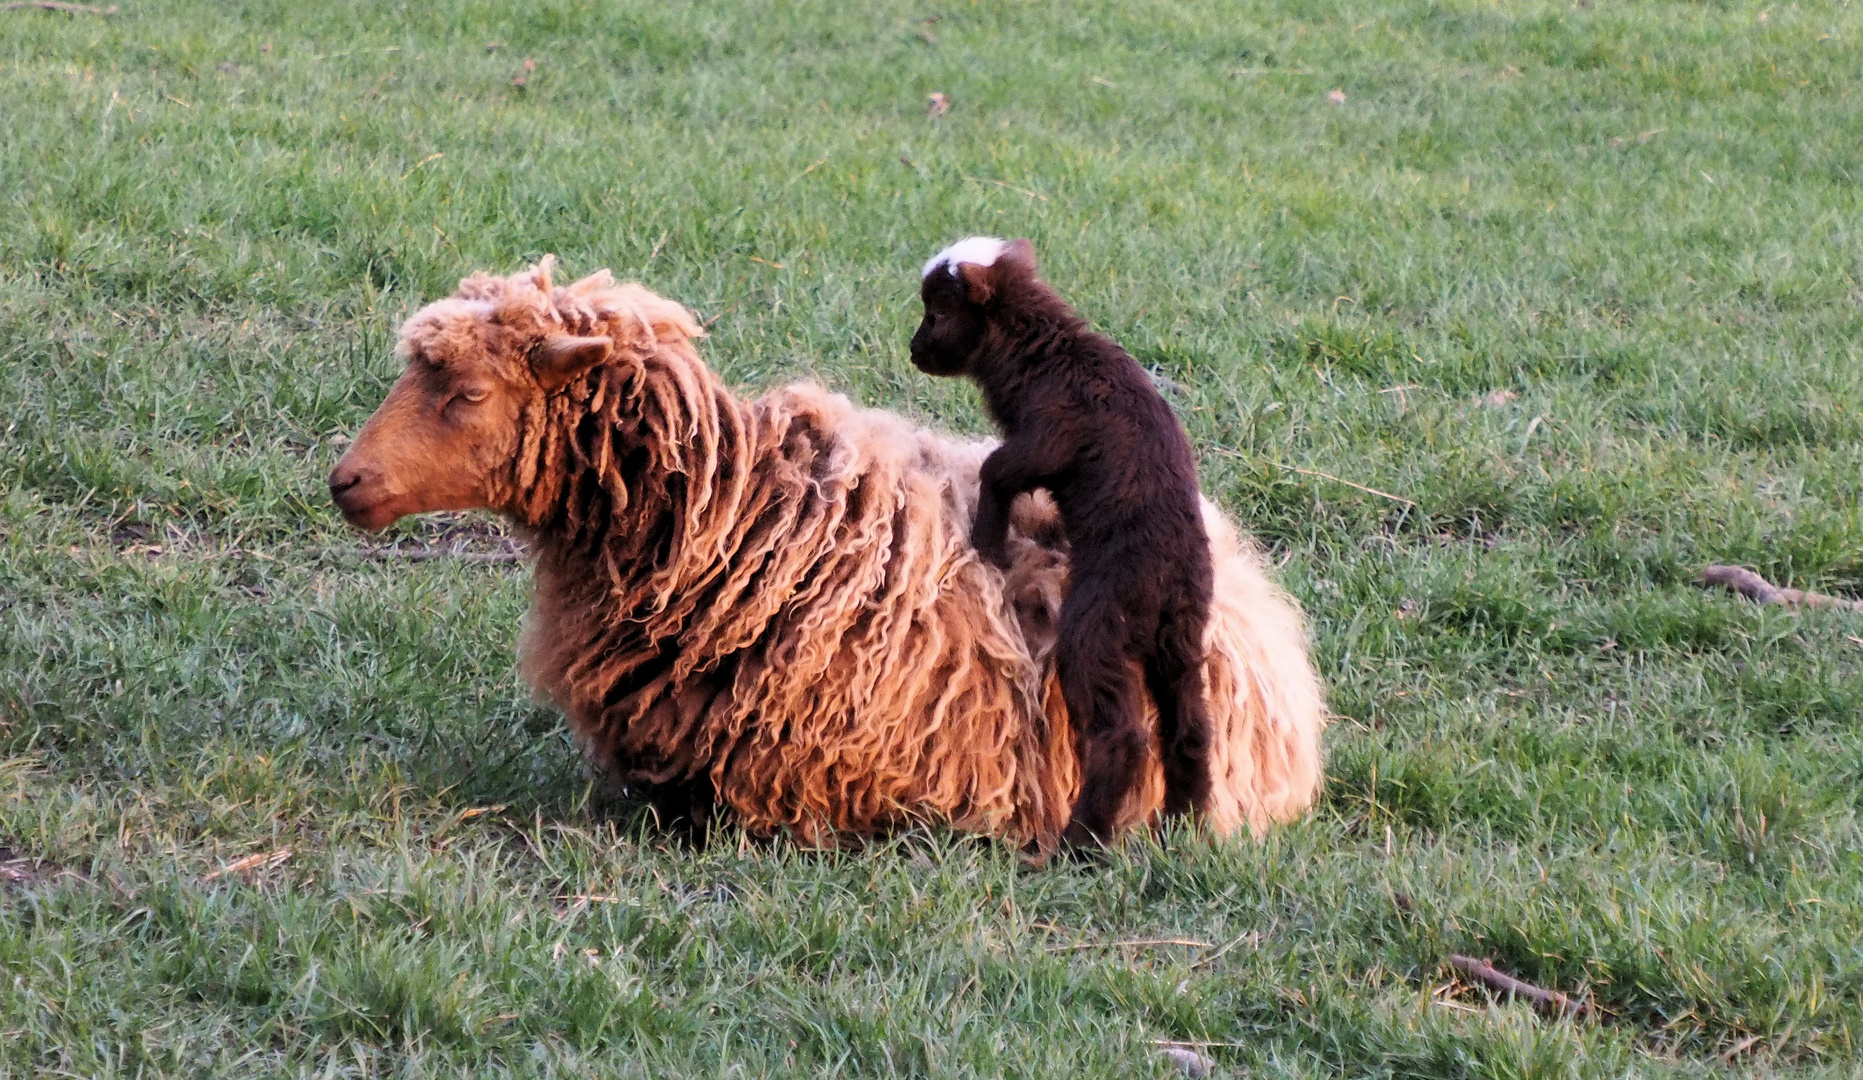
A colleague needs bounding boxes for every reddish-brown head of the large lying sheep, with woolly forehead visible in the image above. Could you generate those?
[330,257,613,531]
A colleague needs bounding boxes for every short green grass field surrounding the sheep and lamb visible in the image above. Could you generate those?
[0,0,1863,1078]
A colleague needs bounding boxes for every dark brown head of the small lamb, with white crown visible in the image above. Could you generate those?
[913,236,1036,374]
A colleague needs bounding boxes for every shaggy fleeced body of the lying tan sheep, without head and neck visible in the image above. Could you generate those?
[525,374,1325,849]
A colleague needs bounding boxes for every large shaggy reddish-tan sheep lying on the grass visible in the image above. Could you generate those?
[330,259,1325,851]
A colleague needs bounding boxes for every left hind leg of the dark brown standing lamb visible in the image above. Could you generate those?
[1054,592,1151,847]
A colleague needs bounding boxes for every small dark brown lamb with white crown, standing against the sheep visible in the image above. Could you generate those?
[911,236,1213,847]
